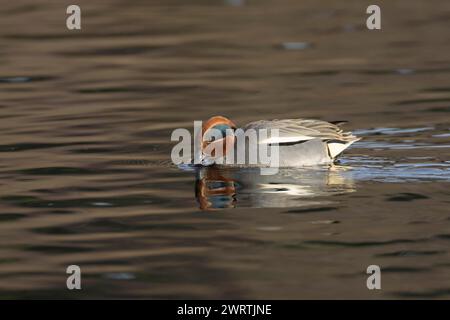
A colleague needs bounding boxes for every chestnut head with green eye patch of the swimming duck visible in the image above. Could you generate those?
[201,116,236,165]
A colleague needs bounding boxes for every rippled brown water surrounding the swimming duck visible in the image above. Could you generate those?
[0,0,450,299]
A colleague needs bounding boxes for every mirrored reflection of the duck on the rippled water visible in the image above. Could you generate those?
[195,166,355,210]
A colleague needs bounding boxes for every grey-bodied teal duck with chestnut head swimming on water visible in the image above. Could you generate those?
[200,116,361,168]
